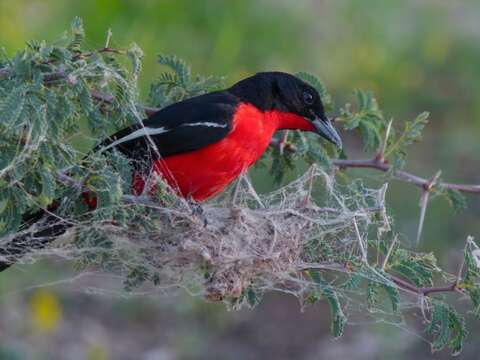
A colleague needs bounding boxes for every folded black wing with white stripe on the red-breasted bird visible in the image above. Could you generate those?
[95,91,238,160]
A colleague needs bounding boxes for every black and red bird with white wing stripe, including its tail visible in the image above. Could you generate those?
[0,72,342,272]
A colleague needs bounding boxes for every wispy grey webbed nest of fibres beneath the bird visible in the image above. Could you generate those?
[11,166,389,305]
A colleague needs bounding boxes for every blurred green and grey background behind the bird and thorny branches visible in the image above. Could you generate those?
[0,0,480,359]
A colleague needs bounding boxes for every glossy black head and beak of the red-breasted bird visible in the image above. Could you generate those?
[229,72,342,148]
